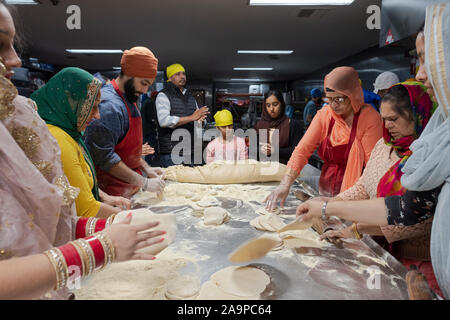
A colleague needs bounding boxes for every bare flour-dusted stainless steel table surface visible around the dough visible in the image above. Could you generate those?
[132,184,408,300]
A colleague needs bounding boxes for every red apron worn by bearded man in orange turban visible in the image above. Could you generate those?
[97,80,143,198]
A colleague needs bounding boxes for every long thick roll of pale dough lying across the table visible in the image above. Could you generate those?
[166,160,286,184]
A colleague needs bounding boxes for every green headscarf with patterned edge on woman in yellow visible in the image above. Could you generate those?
[31,68,102,201]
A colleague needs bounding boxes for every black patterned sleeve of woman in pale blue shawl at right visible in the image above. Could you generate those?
[384,187,441,226]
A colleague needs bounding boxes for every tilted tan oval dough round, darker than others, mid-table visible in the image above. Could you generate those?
[228,234,280,263]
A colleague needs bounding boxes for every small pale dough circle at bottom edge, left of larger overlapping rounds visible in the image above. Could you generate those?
[164,275,200,300]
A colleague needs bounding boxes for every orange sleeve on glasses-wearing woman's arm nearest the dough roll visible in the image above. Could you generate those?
[287,108,331,175]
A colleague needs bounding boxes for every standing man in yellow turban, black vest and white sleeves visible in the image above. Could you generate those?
[156,64,209,167]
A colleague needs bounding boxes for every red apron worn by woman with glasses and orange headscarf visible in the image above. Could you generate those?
[318,112,359,197]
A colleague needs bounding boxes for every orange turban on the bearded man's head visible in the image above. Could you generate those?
[120,47,158,79]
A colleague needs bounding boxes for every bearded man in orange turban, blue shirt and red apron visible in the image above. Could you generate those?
[84,47,165,198]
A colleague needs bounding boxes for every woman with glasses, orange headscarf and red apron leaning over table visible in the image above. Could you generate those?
[265,67,383,210]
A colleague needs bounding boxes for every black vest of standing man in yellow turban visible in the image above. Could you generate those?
[158,82,197,154]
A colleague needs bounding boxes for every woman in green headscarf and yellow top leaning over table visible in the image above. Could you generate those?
[31,68,130,218]
